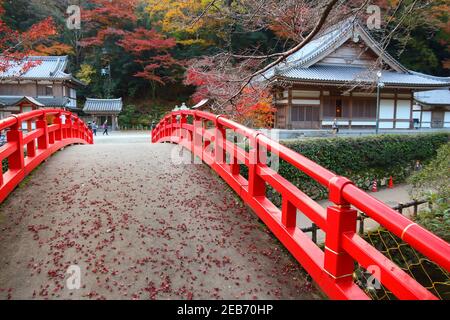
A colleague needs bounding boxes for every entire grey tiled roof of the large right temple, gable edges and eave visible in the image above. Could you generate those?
[255,19,450,88]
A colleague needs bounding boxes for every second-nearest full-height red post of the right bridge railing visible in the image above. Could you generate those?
[248,133,266,197]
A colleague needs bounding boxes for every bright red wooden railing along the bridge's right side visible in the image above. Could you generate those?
[152,110,450,299]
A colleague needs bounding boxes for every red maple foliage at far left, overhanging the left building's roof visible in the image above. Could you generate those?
[0,1,57,73]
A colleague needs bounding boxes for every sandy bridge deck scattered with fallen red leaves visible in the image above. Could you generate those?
[0,135,321,299]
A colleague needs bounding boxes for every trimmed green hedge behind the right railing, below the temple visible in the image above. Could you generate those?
[268,133,450,205]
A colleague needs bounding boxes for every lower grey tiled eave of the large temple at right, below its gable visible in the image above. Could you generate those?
[280,64,450,87]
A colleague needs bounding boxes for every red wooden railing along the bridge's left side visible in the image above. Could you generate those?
[0,109,93,203]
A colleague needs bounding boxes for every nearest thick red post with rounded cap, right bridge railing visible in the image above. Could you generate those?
[324,177,357,284]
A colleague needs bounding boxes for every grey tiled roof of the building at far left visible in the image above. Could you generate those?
[0,56,81,84]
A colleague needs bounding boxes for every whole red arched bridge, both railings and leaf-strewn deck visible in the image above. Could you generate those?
[0,110,450,299]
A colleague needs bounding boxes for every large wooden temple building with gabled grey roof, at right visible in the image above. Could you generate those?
[260,20,450,129]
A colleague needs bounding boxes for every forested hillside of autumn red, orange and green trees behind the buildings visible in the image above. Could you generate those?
[0,0,450,126]
